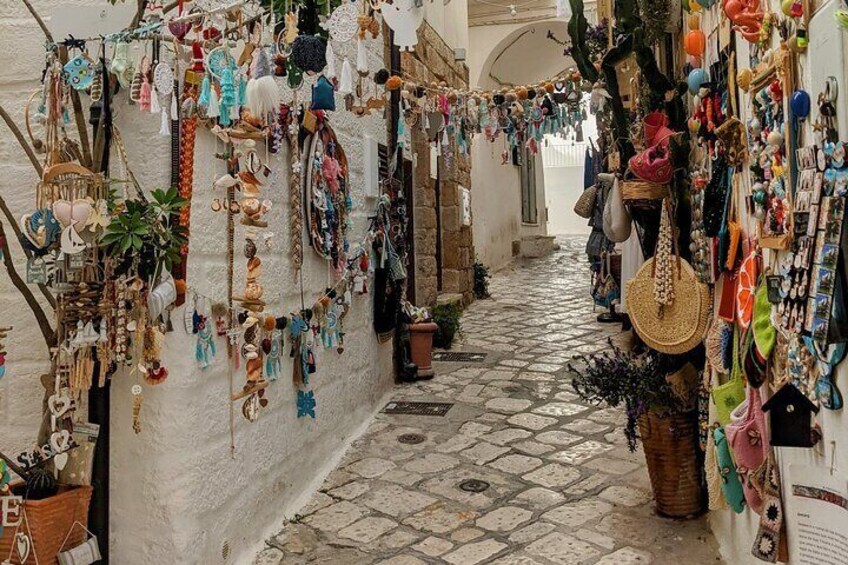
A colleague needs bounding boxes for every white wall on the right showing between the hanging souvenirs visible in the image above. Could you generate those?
[702,0,848,565]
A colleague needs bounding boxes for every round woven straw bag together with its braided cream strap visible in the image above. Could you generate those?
[625,202,711,355]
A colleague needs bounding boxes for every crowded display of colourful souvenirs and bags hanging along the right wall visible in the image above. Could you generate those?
[569,0,848,562]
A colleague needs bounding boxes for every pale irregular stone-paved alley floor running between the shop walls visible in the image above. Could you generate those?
[255,238,721,565]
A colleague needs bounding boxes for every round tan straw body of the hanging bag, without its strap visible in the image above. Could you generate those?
[626,258,710,355]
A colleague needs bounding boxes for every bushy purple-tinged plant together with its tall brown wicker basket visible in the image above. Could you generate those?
[568,342,705,518]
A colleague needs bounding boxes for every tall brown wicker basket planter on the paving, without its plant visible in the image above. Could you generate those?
[639,410,706,518]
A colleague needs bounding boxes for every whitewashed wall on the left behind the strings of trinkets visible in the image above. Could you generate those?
[0,0,392,565]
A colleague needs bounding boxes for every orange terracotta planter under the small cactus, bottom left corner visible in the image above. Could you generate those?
[0,486,92,565]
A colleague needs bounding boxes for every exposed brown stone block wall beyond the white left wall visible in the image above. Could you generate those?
[401,22,474,305]
